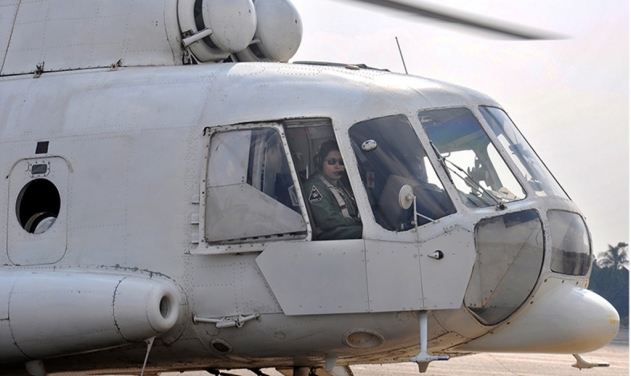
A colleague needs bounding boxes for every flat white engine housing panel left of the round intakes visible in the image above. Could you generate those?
[0,0,176,75]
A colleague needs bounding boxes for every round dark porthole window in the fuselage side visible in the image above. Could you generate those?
[15,179,61,234]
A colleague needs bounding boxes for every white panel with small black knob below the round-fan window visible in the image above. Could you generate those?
[365,227,475,312]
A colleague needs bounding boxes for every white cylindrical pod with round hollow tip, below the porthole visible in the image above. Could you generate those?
[0,272,184,363]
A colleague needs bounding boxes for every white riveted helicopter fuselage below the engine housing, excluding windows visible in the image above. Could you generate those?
[0,63,617,376]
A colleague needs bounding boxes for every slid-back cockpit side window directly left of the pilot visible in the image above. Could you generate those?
[205,128,307,243]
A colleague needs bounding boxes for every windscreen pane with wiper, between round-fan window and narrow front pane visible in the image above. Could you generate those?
[418,108,526,208]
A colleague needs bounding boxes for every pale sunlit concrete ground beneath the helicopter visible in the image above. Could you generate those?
[162,328,629,376]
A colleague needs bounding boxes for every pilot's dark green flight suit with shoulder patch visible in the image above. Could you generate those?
[307,174,362,240]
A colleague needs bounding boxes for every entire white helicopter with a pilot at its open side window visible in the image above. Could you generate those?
[0,0,619,376]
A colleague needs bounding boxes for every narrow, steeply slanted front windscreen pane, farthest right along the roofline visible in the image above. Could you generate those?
[480,107,568,198]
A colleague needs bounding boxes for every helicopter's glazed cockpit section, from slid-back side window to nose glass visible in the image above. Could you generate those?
[200,106,591,325]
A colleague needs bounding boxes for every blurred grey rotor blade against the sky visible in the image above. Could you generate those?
[346,0,567,40]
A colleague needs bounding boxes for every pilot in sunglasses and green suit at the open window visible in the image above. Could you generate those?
[307,140,362,240]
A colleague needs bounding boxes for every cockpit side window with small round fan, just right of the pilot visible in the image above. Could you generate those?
[349,115,456,231]
